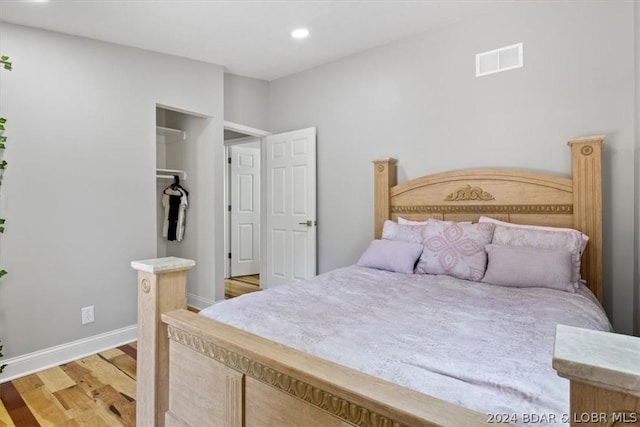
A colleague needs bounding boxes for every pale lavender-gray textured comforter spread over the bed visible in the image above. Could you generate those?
[201,266,610,426]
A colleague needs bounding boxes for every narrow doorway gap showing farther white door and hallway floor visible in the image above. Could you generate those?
[224,122,269,298]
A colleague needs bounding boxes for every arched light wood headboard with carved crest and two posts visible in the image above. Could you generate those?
[373,136,604,301]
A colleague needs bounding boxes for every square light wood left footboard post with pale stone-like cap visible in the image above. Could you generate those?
[131,257,196,427]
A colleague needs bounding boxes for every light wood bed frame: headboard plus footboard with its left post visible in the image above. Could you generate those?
[132,136,604,427]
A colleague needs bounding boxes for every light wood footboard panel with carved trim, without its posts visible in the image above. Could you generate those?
[162,310,486,427]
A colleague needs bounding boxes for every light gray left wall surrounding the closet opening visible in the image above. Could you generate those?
[0,24,224,358]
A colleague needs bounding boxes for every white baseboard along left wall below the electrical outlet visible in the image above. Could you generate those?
[0,325,138,384]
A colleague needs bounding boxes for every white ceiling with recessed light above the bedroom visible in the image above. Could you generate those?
[0,0,514,81]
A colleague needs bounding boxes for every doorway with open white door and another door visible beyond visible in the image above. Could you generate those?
[224,122,317,293]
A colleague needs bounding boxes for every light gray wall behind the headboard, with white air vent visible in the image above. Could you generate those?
[270,1,640,333]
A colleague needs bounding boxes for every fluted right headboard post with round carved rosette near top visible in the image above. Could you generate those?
[569,135,604,301]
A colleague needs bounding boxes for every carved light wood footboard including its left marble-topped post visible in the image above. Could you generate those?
[132,258,487,427]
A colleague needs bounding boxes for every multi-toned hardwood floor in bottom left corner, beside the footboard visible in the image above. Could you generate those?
[0,343,137,427]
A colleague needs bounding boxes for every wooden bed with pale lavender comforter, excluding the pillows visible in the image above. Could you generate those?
[132,136,624,427]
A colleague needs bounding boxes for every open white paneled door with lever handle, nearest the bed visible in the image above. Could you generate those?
[260,128,316,288]
